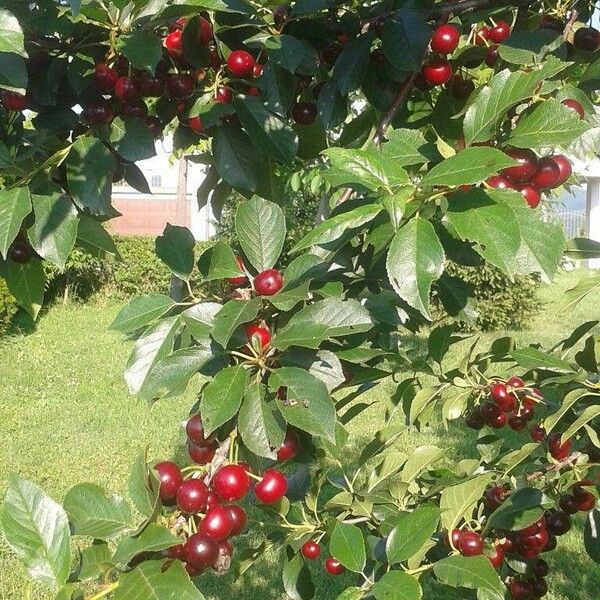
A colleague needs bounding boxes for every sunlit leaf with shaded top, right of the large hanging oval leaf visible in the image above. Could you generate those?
[446,189,521,275]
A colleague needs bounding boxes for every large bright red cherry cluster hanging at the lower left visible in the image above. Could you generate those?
[154,415,290,576]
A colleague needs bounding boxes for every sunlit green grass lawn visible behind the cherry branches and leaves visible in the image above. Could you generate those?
[0,272,600,600]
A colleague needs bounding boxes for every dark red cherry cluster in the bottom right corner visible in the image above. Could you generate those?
[444,480,596,600]
